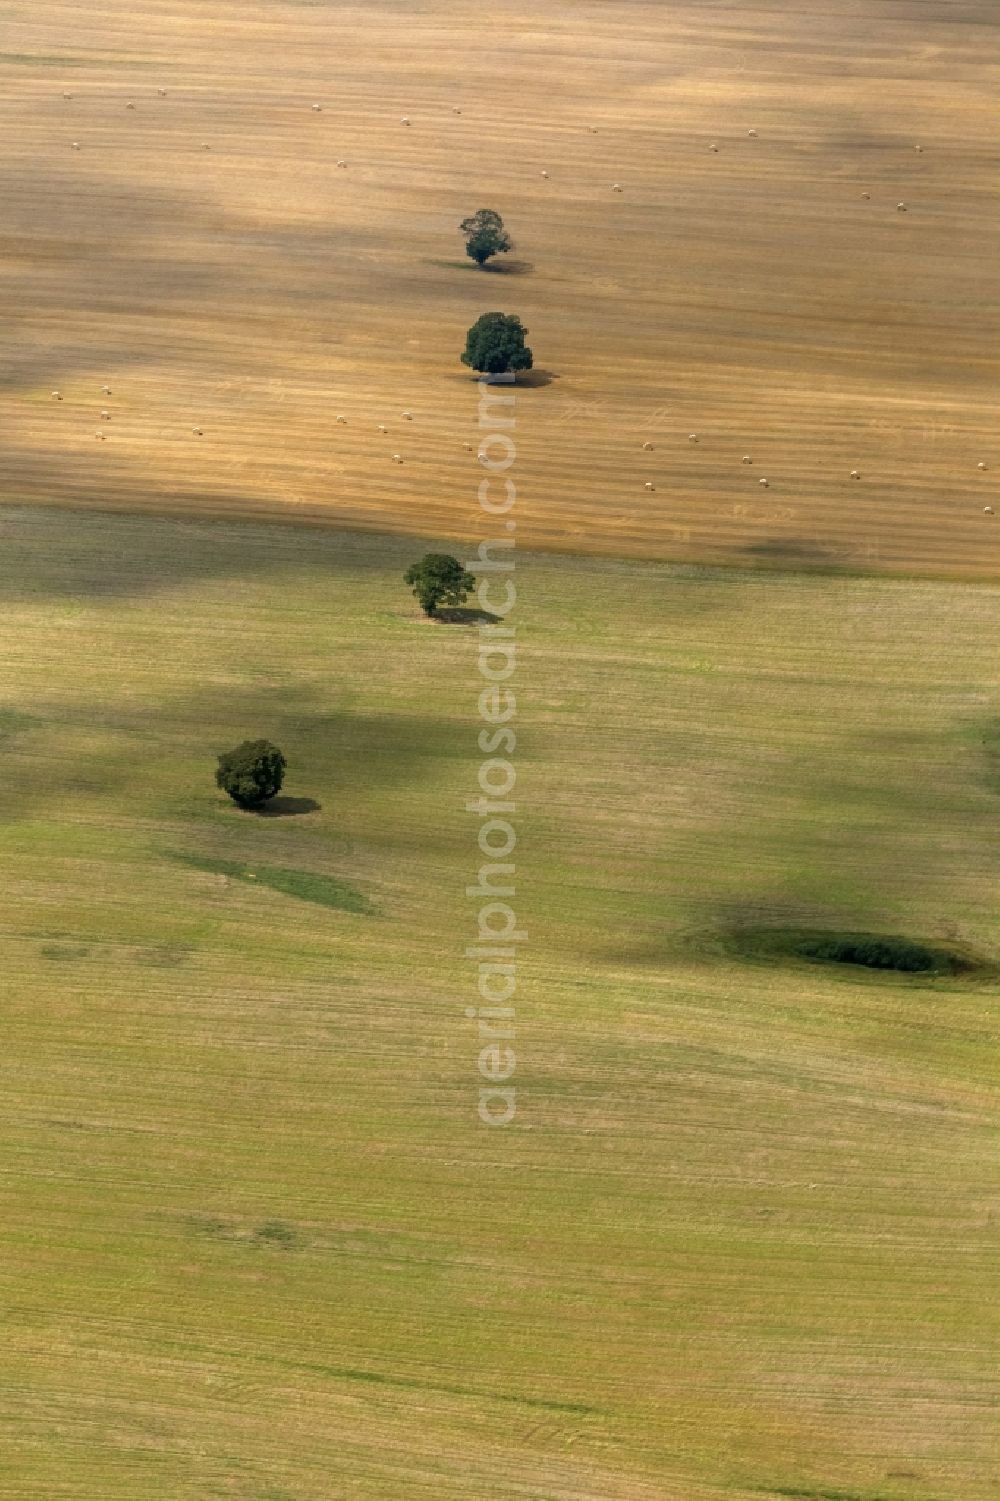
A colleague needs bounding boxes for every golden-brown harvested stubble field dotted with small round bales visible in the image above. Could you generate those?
[0,0,1000,576]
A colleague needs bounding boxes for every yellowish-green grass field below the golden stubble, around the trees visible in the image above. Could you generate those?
[0,509,1000,1501]
